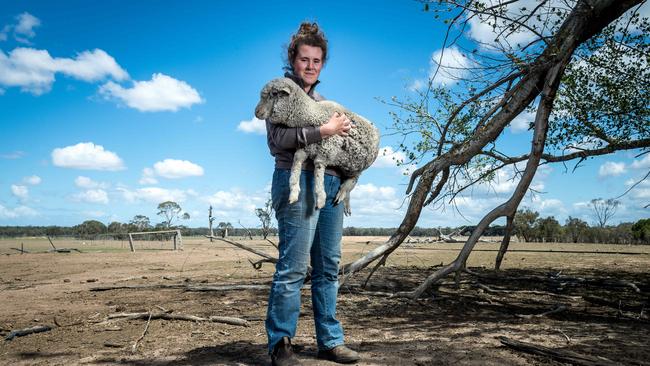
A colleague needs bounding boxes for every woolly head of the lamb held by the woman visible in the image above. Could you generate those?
[255,78,300,123]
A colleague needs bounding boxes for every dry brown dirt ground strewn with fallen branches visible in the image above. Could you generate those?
[0,237,650,366]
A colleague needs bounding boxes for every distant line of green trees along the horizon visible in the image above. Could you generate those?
[0,213,650,244]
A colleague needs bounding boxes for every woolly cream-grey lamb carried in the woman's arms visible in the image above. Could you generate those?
[255,78,379,216]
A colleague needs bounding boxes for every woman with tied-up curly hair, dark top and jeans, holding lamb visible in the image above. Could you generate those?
[266,22,359,365]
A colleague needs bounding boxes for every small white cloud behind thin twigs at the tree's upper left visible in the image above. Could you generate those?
[429,46,472,86]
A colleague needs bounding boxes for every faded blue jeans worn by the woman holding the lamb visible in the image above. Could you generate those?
[266,169,344,353]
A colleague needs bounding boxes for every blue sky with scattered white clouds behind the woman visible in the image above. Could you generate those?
[0,0,650,227]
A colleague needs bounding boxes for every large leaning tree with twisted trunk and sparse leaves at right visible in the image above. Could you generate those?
[341,0,650,297]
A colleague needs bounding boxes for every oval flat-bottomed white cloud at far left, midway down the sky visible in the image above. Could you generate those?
[52,142,124,171]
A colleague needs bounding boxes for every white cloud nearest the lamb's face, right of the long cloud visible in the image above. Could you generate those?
[99,73,203,112]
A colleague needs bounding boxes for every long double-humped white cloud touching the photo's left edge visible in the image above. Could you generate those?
[0,48,128,95]
